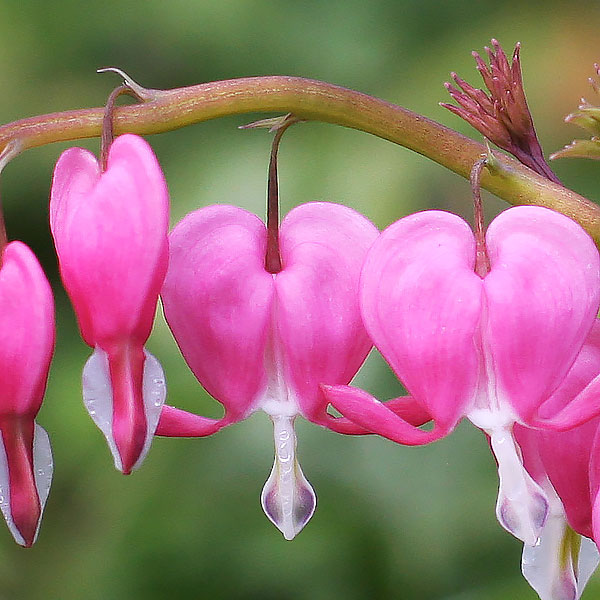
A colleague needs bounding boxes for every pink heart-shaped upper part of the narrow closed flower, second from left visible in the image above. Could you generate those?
[50,134,169,351]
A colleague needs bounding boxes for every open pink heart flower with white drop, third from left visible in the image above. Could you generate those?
[157,203,380,539]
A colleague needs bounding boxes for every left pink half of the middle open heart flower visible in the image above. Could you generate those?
[162,205,274,419]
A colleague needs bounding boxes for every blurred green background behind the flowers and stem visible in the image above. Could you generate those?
[0,0,600,600]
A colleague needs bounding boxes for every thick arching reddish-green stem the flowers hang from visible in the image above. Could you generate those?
[0,76,600,242]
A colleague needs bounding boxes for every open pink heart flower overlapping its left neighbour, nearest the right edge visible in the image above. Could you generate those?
[324,206,600,545]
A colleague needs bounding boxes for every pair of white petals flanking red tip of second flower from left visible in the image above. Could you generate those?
[83,347,167,471]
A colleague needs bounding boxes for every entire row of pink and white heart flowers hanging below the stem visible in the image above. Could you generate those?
[0,130,600,599]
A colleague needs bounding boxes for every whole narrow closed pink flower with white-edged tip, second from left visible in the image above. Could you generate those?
[50,135,169,473]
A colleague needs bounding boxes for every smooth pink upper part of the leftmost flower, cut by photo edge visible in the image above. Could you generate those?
[0,242,54,414]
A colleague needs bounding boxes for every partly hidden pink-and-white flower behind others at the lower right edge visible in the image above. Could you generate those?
[514,320,600,600]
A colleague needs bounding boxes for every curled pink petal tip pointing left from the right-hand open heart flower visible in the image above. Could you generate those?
[321,385,450,446]
